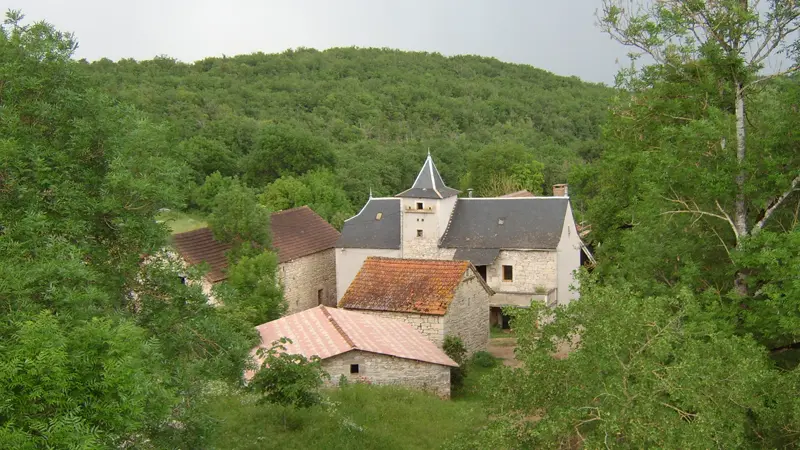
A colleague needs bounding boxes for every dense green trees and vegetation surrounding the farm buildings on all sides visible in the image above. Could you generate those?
[0,0,800,449]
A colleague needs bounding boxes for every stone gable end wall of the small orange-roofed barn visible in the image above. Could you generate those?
[444,271,489,355]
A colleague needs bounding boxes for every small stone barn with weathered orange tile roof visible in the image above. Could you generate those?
[339,256,492,354]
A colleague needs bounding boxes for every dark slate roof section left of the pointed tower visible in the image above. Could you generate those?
[336,198,400,249]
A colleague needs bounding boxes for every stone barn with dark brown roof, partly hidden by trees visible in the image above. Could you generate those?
[173,206,339,314]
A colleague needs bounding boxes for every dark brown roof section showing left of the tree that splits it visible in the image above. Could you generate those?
[172,228,231,283]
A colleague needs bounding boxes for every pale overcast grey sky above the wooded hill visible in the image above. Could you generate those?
[15,0,626,84]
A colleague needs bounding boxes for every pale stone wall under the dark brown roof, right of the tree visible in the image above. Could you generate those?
[278,248,336,315]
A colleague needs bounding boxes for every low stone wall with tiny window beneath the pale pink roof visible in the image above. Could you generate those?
[322,350,450,398]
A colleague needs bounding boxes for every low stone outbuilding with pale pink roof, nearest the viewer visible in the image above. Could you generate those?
[250,306,457,398]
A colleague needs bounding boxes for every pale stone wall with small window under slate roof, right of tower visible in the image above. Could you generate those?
[486,250,558,294]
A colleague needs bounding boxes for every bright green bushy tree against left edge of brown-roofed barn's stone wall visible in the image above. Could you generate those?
[214,252,286,326]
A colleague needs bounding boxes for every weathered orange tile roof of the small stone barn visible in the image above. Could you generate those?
[339,257,491,315]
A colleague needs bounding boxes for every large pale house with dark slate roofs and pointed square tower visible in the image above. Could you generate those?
[336,155,583,323]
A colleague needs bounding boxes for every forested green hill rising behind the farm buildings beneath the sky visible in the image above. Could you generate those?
[82,48,612,223]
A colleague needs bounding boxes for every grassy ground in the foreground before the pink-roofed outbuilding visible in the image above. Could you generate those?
[210,384,487,449]
